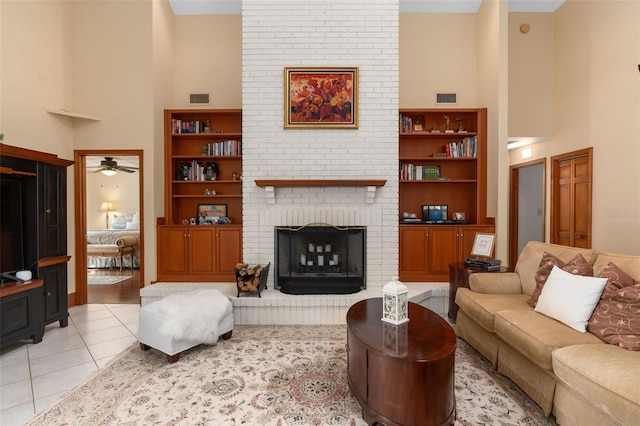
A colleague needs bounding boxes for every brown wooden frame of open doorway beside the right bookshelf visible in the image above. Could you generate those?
[508,158,547,269]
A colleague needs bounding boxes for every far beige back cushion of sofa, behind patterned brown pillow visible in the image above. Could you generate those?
[514,241,595,295]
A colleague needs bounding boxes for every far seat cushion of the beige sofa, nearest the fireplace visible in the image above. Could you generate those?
[456,288,533,333]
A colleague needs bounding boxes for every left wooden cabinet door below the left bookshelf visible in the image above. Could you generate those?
[158,226,189,275]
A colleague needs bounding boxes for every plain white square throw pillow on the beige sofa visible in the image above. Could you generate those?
[534,266,607,333]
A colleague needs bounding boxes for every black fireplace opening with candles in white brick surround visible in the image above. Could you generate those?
[275,225,366,294]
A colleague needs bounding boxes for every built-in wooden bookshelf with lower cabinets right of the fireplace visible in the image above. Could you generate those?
[399,108,494,281]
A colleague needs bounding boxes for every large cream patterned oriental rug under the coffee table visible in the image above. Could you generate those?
[28,326,555,426]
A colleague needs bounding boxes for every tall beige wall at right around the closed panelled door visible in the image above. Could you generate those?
[511,0,640,255]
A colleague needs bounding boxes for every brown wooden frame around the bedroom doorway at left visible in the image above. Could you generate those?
[74,149,144,305]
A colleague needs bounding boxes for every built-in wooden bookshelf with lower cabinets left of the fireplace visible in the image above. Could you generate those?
[158,109,242,281]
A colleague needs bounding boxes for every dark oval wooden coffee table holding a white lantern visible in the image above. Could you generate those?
[347,298,456,426]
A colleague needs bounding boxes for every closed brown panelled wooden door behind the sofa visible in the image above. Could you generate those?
[551,148,592,248]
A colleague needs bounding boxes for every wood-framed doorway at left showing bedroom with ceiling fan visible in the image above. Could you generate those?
[74,150,144,305]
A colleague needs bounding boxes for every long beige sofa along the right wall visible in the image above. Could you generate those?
[455,242,640,425]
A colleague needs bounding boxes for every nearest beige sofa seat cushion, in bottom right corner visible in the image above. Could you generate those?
[552,345,640,425]
